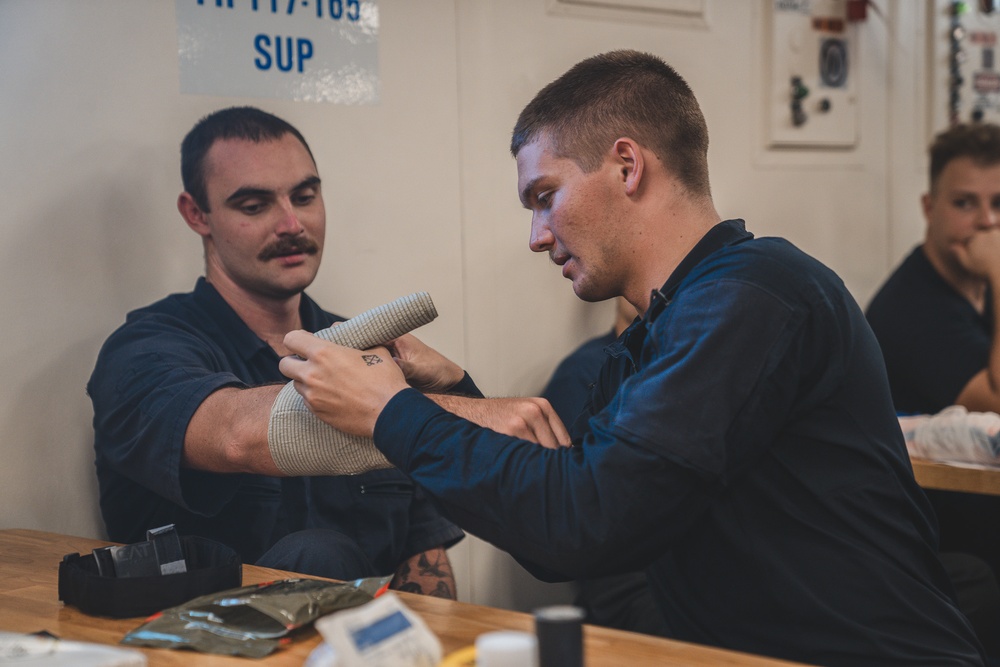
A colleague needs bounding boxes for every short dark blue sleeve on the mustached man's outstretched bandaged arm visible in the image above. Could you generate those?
[87,318,245,516]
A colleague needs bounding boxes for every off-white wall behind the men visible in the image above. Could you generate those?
[0,0,927,609]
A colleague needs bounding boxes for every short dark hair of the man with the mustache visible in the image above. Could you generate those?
[181,107,316,213]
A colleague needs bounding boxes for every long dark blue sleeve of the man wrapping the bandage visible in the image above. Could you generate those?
[375,276,824,578]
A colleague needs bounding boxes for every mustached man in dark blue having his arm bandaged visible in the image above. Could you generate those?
[88,107,462,598]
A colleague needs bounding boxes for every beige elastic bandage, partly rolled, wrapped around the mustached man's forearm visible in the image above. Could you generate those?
[267,292,437,475]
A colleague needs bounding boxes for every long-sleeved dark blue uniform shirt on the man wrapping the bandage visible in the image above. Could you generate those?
[375,221,983,667]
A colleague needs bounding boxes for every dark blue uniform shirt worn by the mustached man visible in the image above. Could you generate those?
[87,278,462,574]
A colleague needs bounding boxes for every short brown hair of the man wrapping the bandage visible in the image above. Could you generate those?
[510,50,711,196]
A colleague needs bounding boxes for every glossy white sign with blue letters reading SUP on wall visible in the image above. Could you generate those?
[176,0,379,104]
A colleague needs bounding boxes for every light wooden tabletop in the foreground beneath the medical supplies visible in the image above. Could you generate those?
[0,530,808,667]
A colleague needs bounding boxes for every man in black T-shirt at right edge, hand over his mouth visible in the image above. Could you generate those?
[865,123,1000,655]
